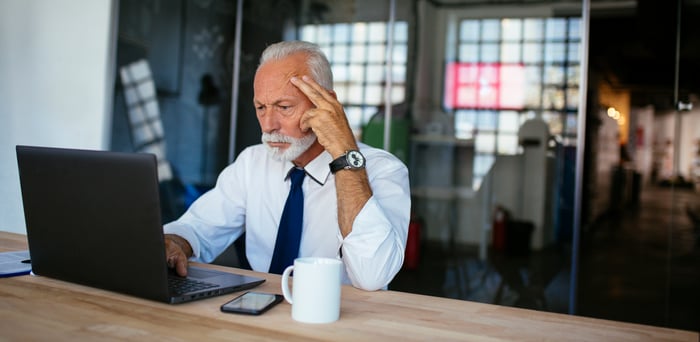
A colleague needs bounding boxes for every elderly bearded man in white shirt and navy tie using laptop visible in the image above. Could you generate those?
[164,41,411,291]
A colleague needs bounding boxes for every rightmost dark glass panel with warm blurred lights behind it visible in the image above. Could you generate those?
[577,1,700,331]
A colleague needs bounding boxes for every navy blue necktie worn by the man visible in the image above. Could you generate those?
[270,167,306,274]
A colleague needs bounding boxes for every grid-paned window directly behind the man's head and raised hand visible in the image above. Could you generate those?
[300,21,408,136]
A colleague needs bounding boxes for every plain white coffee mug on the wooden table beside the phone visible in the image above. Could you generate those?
[282,258,343,323]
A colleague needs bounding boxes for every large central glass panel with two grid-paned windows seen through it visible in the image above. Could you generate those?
[253,1,582,312]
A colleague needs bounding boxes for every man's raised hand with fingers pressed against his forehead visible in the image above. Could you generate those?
[291,76,357,158]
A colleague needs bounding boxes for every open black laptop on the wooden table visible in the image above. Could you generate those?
[16,146,265,303]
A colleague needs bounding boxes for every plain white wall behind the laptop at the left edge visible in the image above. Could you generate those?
[0,0,116,234]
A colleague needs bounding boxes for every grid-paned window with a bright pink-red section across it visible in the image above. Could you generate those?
[443,18,581,188]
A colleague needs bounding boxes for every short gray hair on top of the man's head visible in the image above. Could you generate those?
[258,40,333,90]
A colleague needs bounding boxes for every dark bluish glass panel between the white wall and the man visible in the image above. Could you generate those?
[111,0,236,221]
